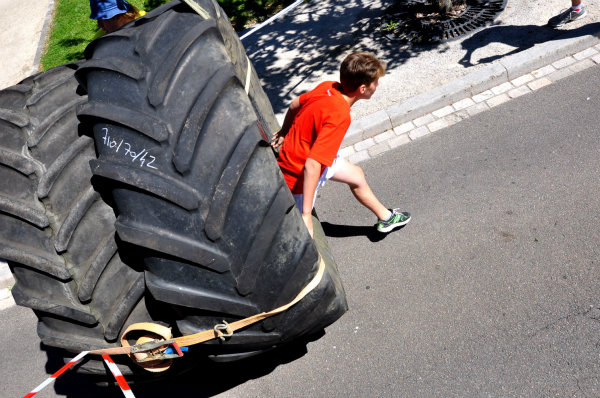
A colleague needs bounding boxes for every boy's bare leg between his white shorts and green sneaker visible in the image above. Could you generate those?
[331,161,391,220]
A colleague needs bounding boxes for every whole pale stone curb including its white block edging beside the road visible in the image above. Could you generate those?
[341,29,600,163]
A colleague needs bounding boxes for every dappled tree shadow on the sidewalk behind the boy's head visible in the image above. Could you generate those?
[242,0,450,114]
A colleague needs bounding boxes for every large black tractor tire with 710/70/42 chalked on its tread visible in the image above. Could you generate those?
[78,0,347,360]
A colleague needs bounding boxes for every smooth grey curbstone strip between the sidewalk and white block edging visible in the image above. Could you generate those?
[342,26,600,151]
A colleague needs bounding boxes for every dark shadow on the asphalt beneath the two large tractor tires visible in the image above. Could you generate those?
[43,332,324,398]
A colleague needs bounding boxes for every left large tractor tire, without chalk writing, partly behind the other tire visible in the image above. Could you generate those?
[0,64,166,374]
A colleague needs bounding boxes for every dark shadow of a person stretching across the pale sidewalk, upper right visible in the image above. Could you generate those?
[459,22,600,68]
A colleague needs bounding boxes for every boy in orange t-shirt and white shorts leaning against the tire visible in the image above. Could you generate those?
[272,52,410,236]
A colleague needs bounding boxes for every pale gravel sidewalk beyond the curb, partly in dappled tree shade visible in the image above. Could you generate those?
[243,0,600,120]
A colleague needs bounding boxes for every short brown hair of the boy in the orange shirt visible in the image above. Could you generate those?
[340,51,386,92]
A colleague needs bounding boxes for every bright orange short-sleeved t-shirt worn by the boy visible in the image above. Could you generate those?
[277,82,350,194]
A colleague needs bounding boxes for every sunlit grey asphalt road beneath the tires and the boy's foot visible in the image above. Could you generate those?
[0,66,600,398]
